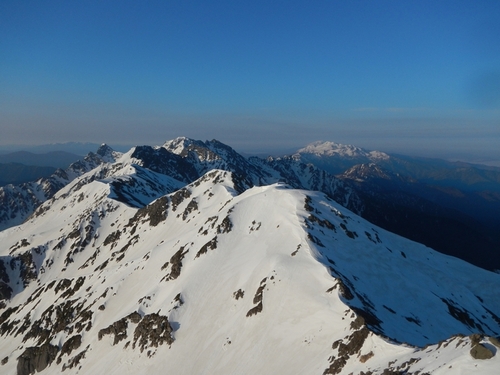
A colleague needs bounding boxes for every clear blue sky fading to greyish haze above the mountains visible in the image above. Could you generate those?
[0,0,500,160]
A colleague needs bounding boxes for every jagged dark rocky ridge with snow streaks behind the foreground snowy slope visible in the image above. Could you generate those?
[0,137,362,230]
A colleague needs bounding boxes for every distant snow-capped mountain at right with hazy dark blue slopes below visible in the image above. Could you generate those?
[291,142,500,270]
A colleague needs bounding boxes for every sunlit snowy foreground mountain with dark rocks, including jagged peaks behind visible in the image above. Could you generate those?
[0,139,500,375]
